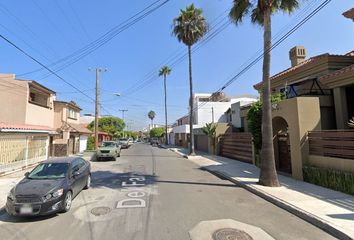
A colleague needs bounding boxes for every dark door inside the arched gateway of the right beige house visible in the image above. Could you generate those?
[278,133,291,174]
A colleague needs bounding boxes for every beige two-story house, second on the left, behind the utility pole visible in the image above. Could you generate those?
[51,101,92,156]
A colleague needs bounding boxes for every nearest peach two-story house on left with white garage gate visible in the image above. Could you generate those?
[0,74,55,172]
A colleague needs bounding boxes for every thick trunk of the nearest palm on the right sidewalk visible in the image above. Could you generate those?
[259,7,279,187]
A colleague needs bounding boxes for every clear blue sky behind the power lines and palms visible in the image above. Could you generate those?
[0,0,354,129]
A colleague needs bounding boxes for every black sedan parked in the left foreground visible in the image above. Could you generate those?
[6,157,91,216]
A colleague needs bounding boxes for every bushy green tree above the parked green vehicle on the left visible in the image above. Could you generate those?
[87,117,125,138]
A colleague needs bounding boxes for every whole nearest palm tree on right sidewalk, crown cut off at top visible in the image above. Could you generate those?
[229,0,299,187]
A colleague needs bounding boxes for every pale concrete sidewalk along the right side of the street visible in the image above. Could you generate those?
[162,146,354,239]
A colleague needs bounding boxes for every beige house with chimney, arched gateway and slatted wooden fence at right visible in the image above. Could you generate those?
[254,46,354,179]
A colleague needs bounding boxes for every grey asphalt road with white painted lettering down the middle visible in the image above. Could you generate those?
[0,144,334,240]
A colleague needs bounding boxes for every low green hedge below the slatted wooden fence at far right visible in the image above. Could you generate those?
[302,166,354,195]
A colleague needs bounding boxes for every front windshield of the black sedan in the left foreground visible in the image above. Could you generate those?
[27,163,69,179]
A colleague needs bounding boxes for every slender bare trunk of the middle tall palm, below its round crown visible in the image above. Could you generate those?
[188,46,195,156]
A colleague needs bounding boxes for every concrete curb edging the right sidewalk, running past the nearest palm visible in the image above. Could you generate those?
[201,167,353,240]
